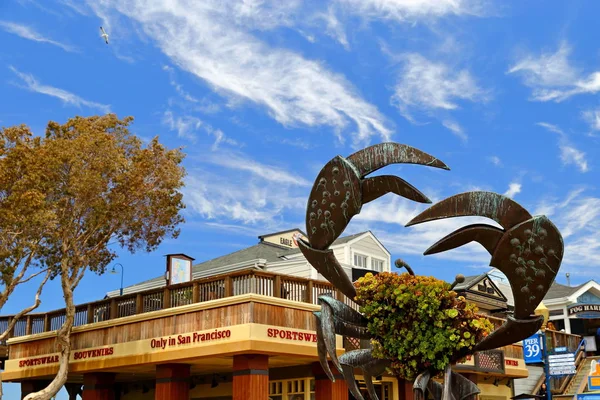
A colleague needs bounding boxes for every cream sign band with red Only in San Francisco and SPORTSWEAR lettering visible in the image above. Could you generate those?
[2,324,343,380]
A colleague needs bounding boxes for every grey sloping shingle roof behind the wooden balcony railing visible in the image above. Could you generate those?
[106,231,365,297]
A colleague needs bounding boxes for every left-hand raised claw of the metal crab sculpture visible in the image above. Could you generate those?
[298,143,449,299]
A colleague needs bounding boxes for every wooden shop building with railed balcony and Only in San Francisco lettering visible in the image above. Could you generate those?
[0,230,527,400]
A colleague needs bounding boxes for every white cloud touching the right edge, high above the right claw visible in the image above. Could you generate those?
[508,42,600,102]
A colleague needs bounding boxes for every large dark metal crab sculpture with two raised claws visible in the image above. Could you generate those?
[298,143,563,400]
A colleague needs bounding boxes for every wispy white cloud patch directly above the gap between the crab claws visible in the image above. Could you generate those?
[392,53,487,138]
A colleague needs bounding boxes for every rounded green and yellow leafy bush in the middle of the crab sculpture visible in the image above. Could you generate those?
[355,272,493,381]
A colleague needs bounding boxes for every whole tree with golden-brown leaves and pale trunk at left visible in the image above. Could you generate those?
[0,114,185,400]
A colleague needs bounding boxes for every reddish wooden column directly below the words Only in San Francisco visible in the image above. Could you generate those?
[154,364,190,400]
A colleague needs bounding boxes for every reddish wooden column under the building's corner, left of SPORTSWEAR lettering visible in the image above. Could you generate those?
[233,354,269,400]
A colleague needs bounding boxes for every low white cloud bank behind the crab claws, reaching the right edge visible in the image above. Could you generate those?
[354,187,600,275]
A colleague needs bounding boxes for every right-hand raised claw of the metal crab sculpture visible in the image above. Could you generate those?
[406,192,564,350]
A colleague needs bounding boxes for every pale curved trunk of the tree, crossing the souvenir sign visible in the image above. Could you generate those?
[24,268,75,400]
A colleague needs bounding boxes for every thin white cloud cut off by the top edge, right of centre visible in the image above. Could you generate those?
[335,0,485,21]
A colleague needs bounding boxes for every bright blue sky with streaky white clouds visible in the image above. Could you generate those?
[0,0,600,398]
